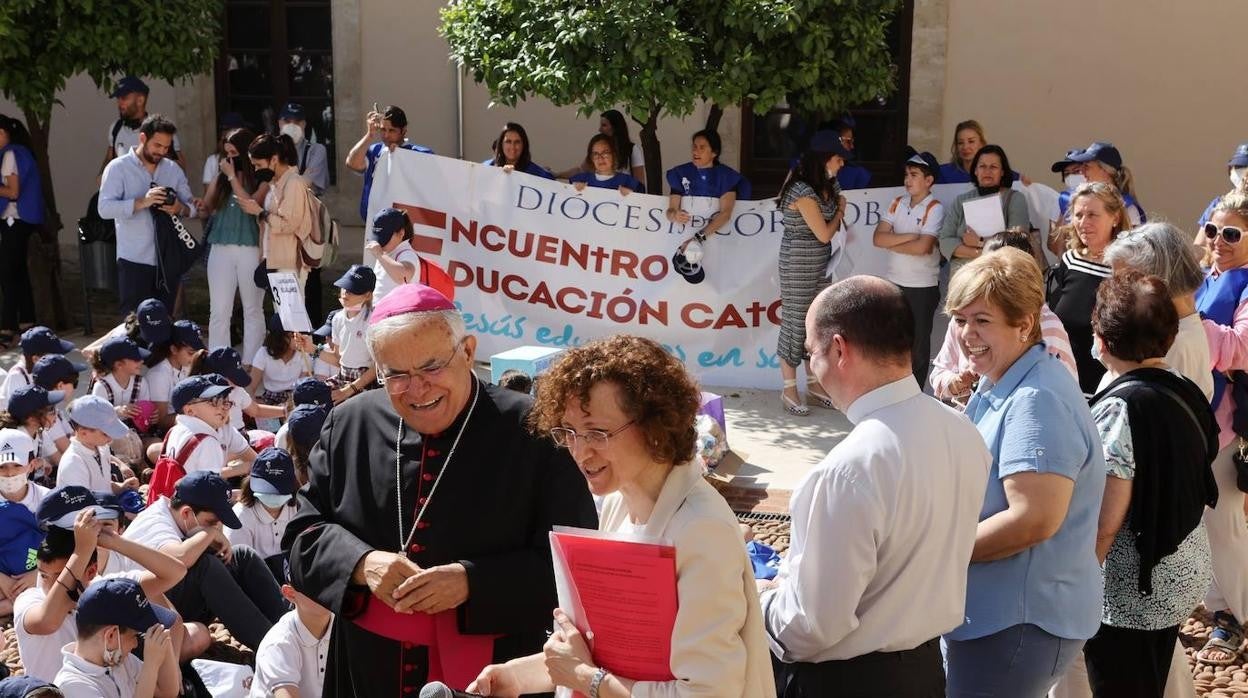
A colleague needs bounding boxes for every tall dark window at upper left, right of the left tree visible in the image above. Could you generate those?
[216,0,338,184]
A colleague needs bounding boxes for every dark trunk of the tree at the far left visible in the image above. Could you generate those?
[21,109,70,330]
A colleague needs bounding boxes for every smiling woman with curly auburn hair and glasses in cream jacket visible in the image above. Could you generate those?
[468,336,775,698]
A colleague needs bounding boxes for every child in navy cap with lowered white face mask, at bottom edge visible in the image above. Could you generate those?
[52,578,182,698]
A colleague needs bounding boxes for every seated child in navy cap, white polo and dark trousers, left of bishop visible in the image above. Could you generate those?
[124,471,290,647]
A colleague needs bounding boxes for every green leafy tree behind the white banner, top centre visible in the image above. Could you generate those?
[442,0,900,191]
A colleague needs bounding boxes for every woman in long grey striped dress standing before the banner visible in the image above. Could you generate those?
[776,131,850,417]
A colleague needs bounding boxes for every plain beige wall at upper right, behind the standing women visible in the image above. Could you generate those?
[938,0,1248,231]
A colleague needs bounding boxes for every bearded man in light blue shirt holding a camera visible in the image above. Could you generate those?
[99,114,202,315]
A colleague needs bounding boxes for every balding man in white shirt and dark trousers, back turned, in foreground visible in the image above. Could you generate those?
[761,276,992,698]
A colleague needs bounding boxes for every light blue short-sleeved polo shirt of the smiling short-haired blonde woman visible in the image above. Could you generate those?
[946,345,1106,641]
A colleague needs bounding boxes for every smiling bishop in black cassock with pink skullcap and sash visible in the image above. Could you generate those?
[285,282,598,698]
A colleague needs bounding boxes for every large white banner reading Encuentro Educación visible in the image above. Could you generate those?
[368,150,1053,387]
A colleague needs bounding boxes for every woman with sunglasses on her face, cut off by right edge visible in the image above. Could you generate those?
[1196,191,1248,666]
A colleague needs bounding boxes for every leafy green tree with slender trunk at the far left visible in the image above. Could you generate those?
[0,0,222,326]
